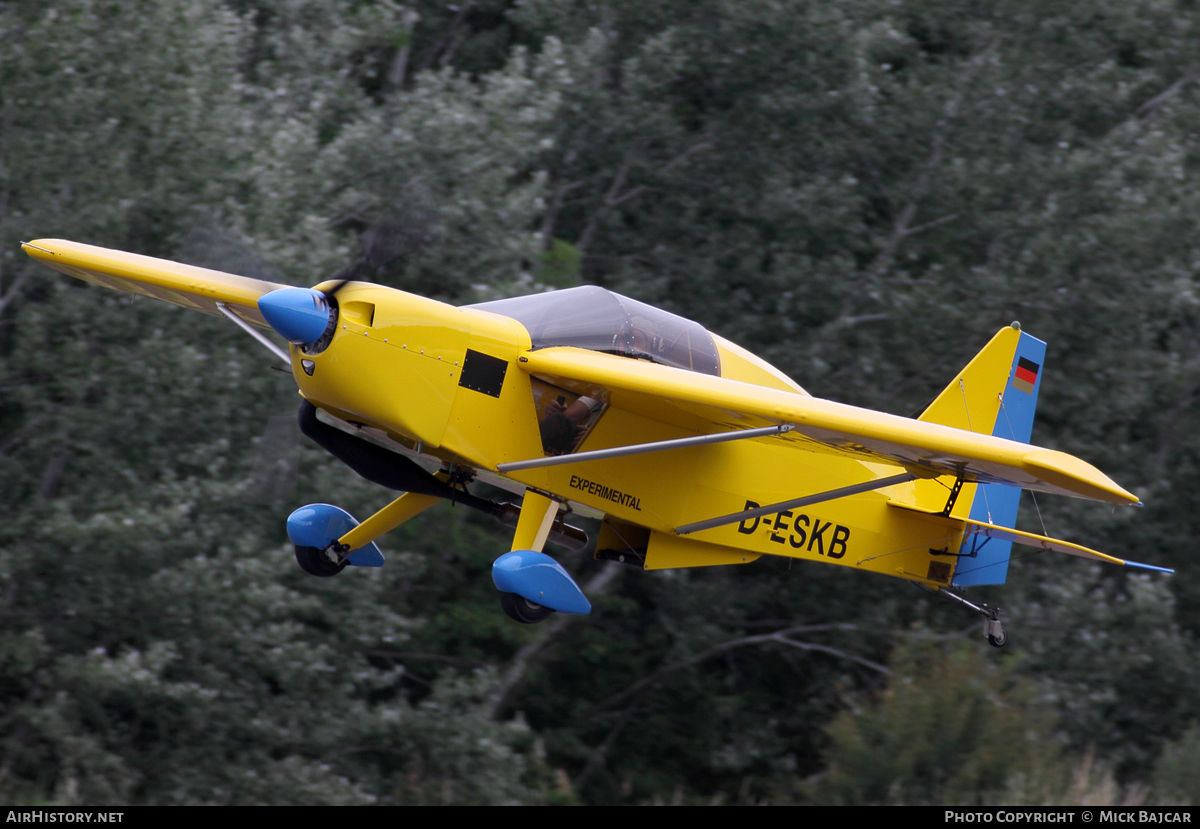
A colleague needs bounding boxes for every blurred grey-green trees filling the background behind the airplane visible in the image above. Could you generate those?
[0,0,1200,804]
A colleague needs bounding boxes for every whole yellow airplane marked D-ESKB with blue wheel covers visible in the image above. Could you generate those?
[24,239,1171,647]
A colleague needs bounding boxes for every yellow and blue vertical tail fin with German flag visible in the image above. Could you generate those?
[902,323,1046,585]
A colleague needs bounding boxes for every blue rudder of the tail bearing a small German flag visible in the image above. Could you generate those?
[952,331,1046,587]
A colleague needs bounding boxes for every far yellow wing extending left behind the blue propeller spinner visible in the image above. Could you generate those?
[22,239,288,328]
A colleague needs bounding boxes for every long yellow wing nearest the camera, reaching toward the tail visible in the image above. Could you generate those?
[518,348,1139,504]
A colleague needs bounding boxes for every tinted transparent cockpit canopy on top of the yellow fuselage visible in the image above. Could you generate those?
[466,286,721,377]
